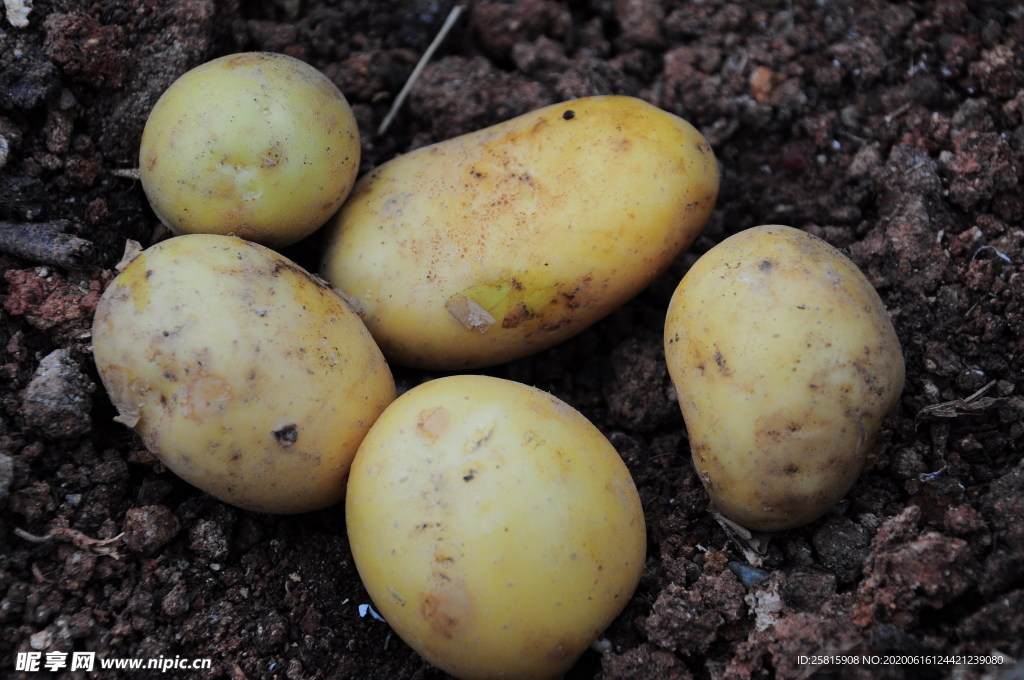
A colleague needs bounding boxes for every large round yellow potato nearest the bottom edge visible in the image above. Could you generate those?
[345,376,646,680]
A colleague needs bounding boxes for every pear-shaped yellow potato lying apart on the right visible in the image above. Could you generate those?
[665,226,903,532]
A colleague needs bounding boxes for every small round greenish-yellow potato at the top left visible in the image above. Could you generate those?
[139,52,359,248]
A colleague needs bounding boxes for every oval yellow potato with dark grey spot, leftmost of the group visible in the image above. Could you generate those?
[92,235,395,513]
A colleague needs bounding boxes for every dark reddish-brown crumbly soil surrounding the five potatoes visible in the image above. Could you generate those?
[0,0,1024,680]
